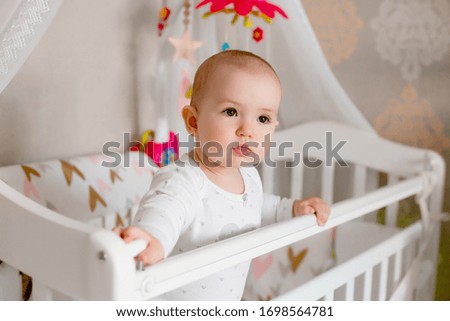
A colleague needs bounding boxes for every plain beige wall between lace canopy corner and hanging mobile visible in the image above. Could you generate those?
[0,0,157,165]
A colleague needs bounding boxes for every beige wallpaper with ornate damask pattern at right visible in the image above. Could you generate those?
[302,0,450,300]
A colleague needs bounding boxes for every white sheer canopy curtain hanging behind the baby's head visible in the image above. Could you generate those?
[152,0,372,139]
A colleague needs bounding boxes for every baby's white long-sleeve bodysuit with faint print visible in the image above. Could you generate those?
[134,155,293,300]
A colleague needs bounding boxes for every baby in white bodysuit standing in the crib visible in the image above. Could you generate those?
[114,50,330,300]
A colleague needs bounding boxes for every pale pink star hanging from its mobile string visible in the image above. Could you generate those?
[169,0,202,65]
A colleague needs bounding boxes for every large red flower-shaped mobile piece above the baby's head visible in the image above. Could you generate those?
[195,0,288,28]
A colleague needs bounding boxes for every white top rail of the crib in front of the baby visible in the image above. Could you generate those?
[135,177,423,300]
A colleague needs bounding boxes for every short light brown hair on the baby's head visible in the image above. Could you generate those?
[191,50,280,108]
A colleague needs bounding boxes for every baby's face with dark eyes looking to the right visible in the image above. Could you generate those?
[195,67,281,167]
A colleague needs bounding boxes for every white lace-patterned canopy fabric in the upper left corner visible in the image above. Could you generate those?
[0,0,63,93]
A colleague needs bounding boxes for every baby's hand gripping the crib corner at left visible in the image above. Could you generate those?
[113,226,164,266]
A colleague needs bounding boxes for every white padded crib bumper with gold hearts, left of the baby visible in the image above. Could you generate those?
[0,152,157,224]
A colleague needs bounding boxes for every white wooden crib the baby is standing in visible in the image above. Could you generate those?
[0,122,445,300]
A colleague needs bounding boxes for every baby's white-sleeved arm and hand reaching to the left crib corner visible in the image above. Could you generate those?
[115,159,203,265]
